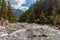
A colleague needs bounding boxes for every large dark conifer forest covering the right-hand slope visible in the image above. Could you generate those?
[19,0,60,24]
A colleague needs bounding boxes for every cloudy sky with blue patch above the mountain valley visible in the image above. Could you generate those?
[6,0,36,11]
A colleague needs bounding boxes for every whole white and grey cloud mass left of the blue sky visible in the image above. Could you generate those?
[7,0,28,11]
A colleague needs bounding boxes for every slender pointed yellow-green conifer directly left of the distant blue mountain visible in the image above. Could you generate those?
[7,1,16,22]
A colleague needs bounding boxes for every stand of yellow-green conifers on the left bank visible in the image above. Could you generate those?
[0,0,16,22]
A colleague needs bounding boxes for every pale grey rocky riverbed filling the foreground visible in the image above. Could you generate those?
[0,23,60,40]
